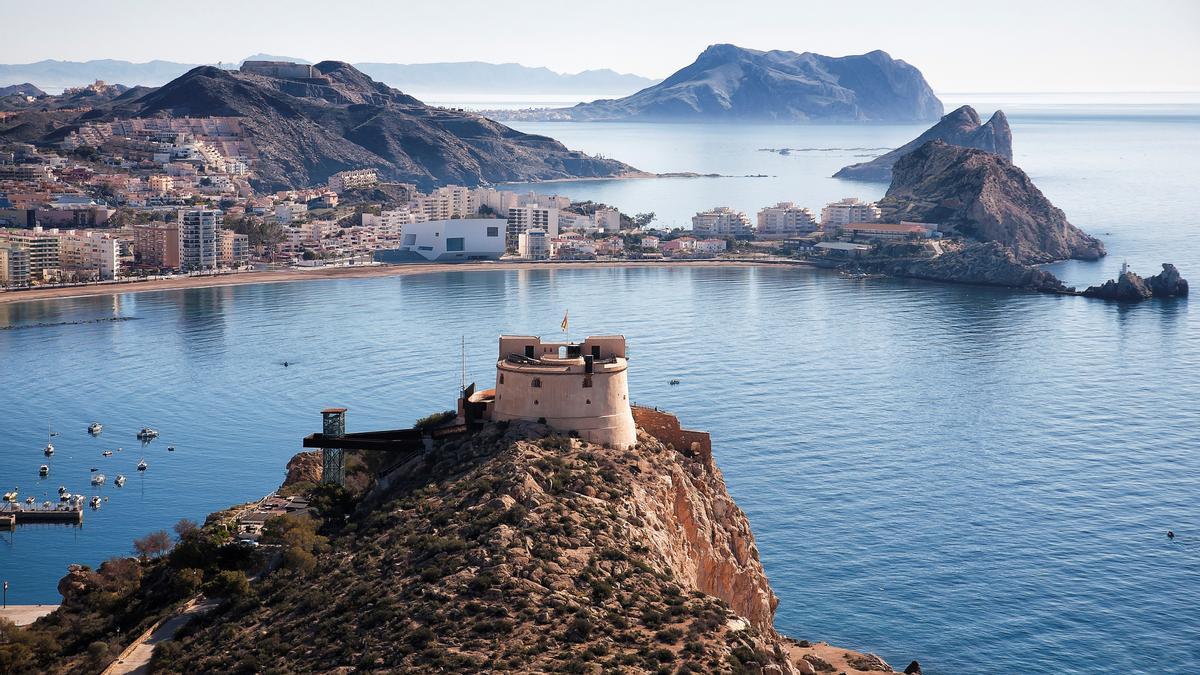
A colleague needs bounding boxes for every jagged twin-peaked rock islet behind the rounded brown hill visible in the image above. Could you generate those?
[833,106,1013,183]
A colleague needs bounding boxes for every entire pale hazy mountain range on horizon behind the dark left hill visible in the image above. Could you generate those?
[0,54,658,95]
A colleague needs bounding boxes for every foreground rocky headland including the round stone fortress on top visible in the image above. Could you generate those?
[0,336,920,675]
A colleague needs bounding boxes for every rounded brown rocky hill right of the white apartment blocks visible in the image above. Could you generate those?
[880,141,1105,264]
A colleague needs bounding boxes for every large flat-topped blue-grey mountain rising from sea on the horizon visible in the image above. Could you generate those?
[554,44,942,121]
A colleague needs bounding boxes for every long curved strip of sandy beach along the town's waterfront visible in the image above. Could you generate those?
[0,259,804,304]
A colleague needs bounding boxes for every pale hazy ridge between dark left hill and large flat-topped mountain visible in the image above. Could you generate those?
[355,61,658,94]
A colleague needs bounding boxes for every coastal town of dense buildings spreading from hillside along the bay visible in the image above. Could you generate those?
[0,109,941,291]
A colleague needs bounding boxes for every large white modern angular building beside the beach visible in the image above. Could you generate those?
[376,219,505,262]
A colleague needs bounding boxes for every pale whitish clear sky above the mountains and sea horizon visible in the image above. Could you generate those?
[7,0,1200,92]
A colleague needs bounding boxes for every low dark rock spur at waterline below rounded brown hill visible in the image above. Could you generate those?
[882,241,1068,292]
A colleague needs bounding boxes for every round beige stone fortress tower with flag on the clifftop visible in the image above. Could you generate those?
[468,335,637,448]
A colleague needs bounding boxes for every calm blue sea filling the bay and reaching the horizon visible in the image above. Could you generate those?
[0,94,1200,675]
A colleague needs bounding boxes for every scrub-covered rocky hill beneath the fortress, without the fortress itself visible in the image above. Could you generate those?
[157,423,907,675]
